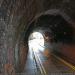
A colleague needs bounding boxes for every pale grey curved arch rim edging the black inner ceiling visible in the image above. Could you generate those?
[29,9,74,25]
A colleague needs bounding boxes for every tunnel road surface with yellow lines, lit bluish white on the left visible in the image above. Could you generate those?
[24,39,73,75]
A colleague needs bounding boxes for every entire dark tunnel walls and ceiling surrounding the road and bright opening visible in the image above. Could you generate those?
[0,0,75,75]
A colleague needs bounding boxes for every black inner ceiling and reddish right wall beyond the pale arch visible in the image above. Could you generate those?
[24,15,75,69]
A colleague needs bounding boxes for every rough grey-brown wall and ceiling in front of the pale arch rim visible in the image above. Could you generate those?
[0,0,75,72]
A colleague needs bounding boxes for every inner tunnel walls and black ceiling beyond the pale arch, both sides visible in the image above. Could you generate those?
[13,15,75,72]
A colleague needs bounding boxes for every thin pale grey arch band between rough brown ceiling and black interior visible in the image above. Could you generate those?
[23,9,75,41]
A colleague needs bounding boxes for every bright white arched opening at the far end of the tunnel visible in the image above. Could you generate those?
[28,32,44,52]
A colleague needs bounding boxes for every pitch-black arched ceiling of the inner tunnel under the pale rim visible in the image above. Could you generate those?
[26,15,73,42]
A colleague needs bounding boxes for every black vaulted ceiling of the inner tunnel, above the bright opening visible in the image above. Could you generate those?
[26,15,74,43]
